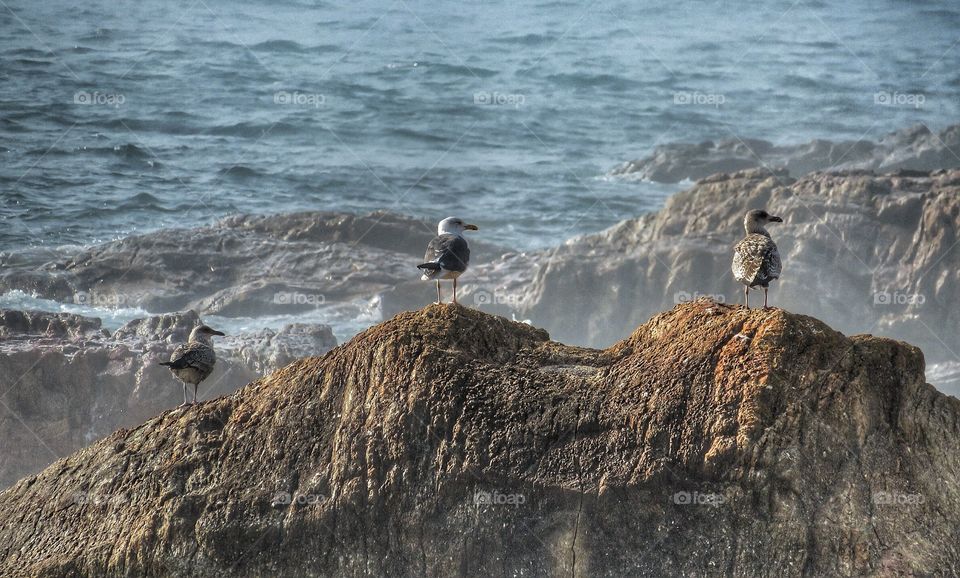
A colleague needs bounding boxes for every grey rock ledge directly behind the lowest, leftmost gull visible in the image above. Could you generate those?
[0,310,336,488]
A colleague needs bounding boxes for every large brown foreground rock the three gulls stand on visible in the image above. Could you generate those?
[0,300,960,577]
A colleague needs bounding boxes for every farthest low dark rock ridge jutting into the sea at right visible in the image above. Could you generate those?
[611,125,960,183]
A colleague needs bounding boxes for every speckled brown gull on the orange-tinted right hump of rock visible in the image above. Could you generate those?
[732,209,783,309]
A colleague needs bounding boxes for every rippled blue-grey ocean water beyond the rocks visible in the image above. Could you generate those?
[0,0,960,336]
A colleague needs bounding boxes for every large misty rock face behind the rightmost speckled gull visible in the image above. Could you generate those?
[524,170,960,396]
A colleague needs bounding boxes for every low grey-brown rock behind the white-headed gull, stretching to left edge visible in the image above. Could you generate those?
[0,212,529,317]
